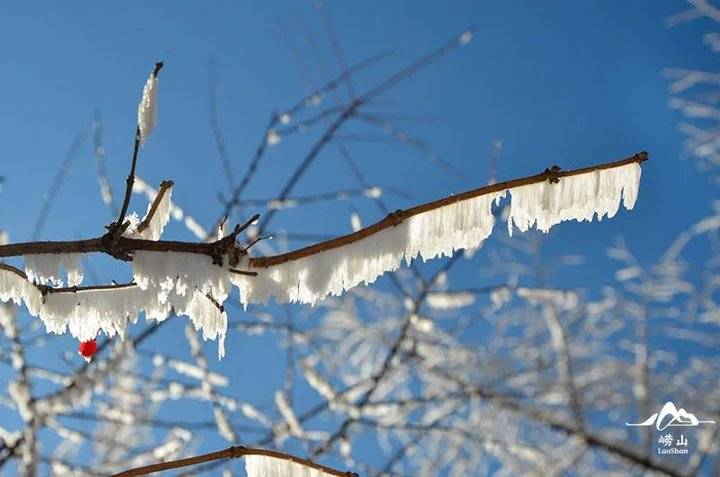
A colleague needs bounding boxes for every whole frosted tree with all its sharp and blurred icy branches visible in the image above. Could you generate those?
[0,5,720,476]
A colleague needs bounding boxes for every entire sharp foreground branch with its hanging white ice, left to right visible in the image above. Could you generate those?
[0,153,647,357]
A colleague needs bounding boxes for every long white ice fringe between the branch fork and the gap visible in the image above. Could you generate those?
[230,191,505,305]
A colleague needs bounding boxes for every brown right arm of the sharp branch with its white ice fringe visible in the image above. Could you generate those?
[238,152,648,304]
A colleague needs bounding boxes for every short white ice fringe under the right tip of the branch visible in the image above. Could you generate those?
[508,162,641,235]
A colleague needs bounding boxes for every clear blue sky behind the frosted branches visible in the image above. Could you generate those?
[0,0,717,472]
